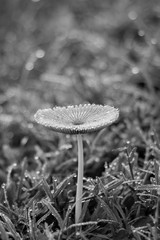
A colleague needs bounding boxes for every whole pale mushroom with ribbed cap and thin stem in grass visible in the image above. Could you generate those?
[34,104,119,223]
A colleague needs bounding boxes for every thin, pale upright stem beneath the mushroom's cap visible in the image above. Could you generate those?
[75,134,84,223]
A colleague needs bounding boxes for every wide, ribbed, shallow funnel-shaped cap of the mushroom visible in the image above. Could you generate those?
[34,104,119,134]
